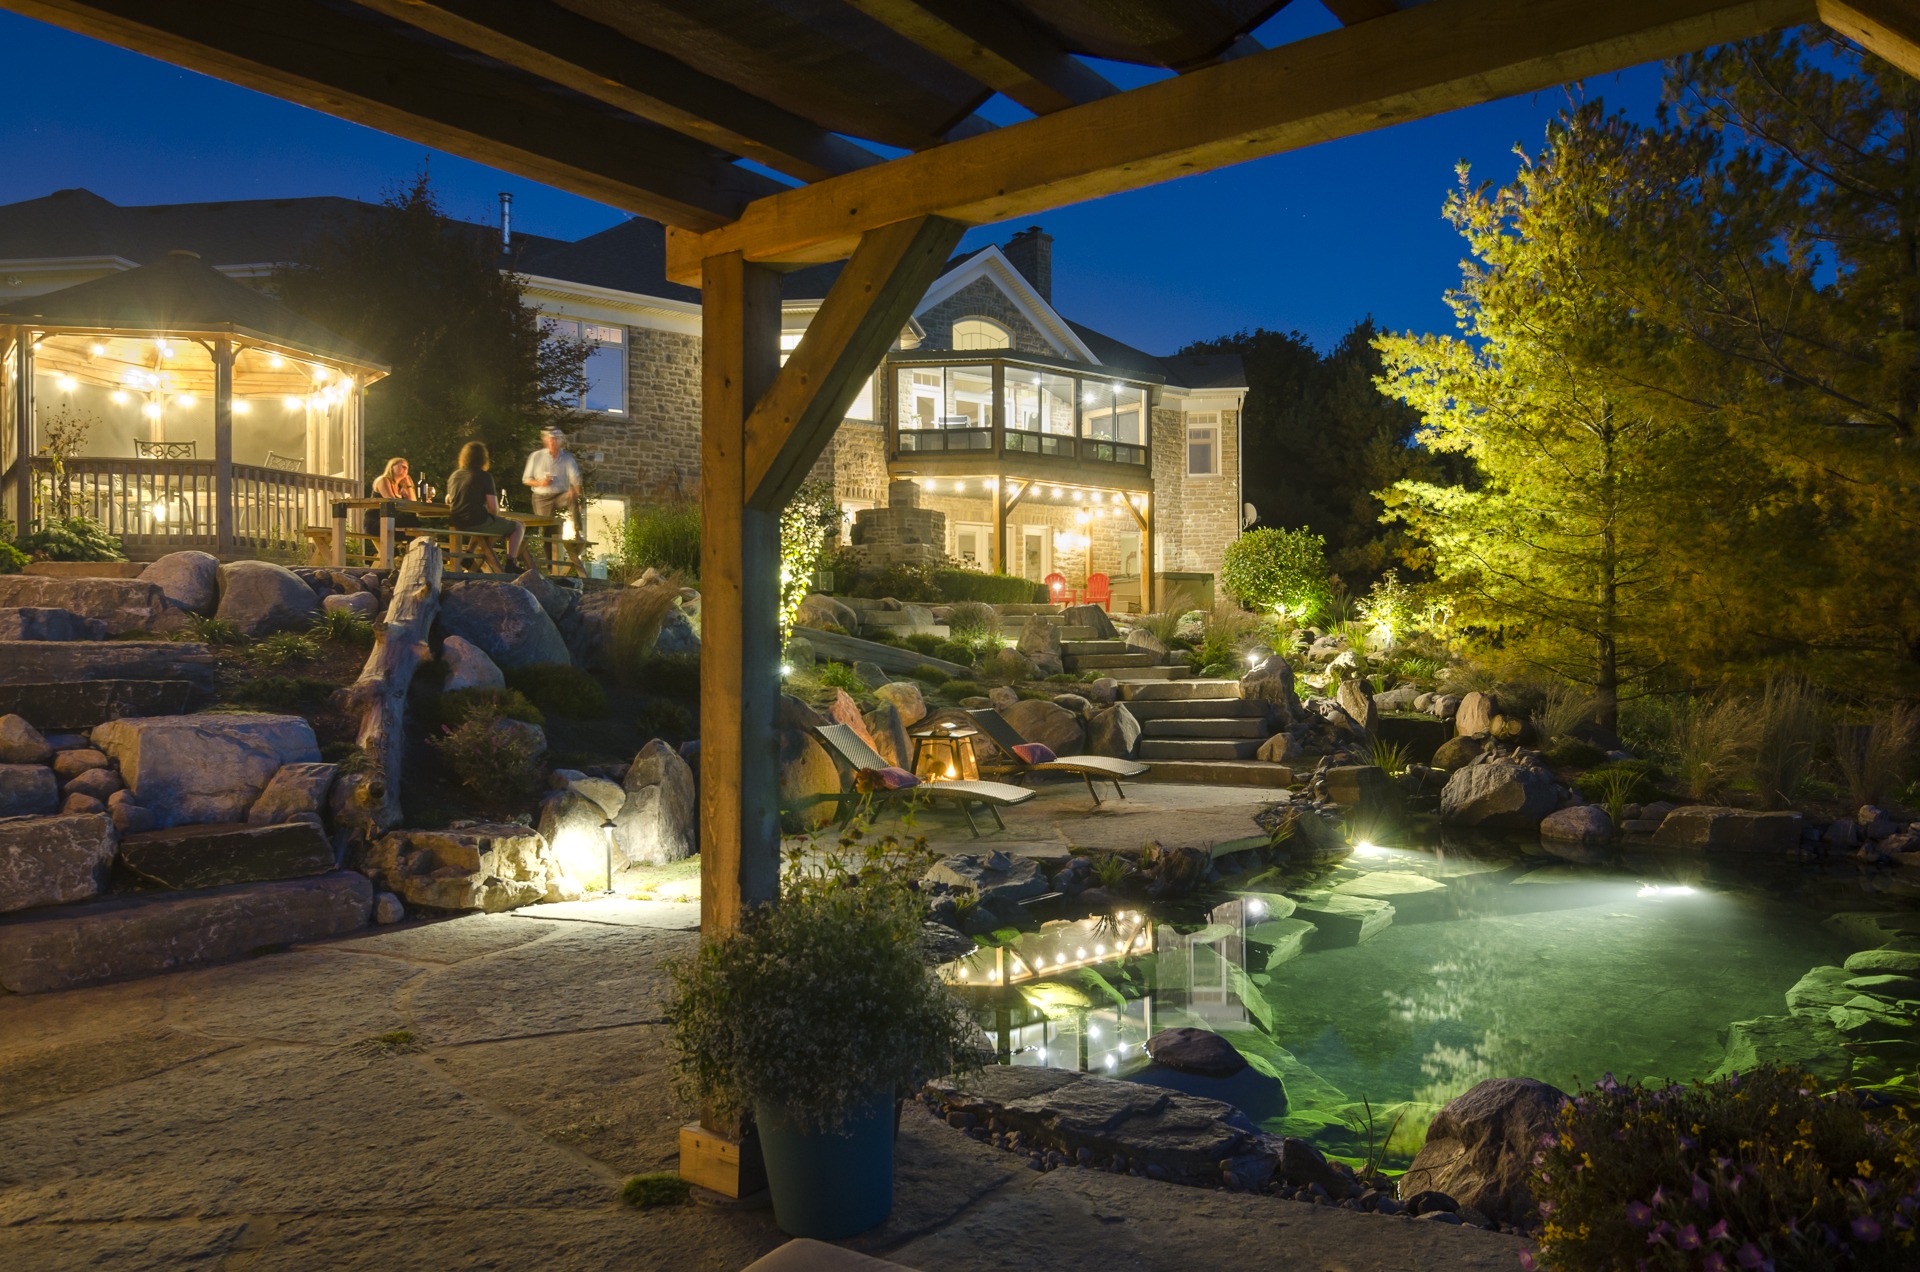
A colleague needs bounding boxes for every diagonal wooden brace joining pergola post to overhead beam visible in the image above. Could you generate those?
[747,217,966,515]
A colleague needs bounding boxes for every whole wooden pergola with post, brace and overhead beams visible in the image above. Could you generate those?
[0,0,1920,1183]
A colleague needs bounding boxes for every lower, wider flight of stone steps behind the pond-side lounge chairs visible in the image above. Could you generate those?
[1119,684,1292,786]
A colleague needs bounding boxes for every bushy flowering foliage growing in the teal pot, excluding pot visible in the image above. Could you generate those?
[666,832,977,1130]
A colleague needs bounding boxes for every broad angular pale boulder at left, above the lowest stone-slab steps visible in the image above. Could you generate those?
[92,713,321,828]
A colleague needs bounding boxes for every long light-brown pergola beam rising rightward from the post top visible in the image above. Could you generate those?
[666,0,1814,282]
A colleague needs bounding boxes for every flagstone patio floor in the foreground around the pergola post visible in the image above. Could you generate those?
[0,901,1519,1272]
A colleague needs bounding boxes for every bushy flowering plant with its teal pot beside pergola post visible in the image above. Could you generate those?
[666,842,975,1239]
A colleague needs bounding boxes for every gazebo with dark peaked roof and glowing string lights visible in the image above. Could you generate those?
[0,252,386,559]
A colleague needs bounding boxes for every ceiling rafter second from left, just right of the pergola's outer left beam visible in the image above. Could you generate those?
[359,0,879,181]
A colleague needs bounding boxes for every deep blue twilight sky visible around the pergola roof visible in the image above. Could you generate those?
[0,4,1661,354]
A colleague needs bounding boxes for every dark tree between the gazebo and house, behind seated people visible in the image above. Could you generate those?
[275,171,586,490]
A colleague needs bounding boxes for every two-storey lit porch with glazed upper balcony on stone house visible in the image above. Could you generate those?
[881,350,1160,601]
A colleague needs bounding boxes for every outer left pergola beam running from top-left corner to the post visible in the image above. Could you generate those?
[0,0,783,227]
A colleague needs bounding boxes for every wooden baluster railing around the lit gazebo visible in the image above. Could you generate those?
[33,457,357,557]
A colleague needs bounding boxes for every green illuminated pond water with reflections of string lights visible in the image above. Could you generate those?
[952,840,1920,1164]
